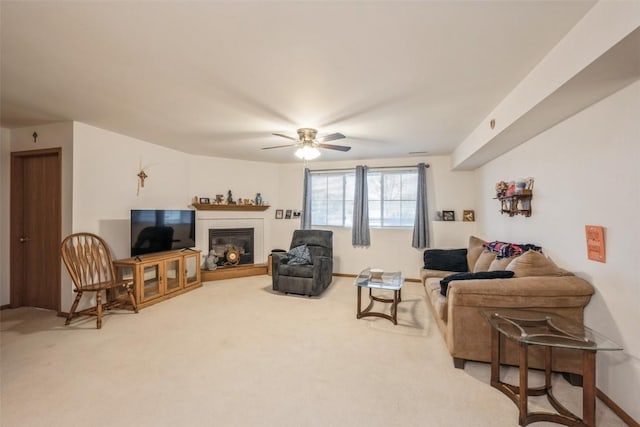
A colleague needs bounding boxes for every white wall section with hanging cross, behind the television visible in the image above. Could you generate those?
[73,122,190,258]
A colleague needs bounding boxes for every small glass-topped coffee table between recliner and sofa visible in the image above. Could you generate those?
[353,268,404,325]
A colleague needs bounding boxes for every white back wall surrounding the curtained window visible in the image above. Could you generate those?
[273,157,475,278]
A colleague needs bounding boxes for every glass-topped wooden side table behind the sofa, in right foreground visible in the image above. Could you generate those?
[480,309,622,427]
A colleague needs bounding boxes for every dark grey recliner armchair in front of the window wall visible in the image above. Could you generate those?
[271,230,333,296]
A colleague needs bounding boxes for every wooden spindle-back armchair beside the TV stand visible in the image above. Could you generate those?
[60,233,138,329]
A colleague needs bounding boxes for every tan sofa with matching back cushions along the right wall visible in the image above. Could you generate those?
[421,236,594,374]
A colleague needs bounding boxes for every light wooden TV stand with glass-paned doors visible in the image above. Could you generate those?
[113,249,202,308]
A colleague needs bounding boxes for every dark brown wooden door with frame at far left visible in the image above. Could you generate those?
[10,148,62,311]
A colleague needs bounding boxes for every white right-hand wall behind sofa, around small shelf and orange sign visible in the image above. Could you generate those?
[476,82,640,420]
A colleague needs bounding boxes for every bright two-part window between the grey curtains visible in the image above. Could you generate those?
[311,169,418,227]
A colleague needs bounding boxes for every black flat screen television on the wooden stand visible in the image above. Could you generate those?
[131,209,196,257]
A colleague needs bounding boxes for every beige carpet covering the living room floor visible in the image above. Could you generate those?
[0,276,624,427]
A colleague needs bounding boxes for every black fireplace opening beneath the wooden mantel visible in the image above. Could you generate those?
[209,228,254,266]
